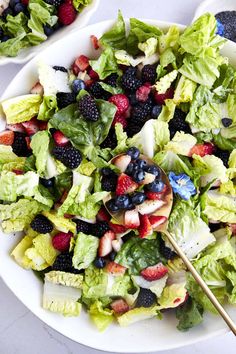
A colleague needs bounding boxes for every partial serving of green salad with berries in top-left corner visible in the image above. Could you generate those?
[0,0,92,57]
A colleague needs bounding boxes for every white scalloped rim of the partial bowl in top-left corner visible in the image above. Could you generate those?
[0,0,100,65]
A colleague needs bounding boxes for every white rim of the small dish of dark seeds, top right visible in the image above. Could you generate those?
[193,0,236,21]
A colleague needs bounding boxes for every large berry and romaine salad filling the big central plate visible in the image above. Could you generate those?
[0,13,236,331]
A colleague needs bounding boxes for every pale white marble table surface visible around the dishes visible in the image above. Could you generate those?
[0,0,235,354]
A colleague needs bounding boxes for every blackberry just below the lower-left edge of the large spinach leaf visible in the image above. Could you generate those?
[52,146,82,169]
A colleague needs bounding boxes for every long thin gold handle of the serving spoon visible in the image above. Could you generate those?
[165,231,236,336]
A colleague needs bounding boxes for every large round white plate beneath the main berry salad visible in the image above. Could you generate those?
[0,20,236,353]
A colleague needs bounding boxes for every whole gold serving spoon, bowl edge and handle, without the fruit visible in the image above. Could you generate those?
[104,154,236,335]
